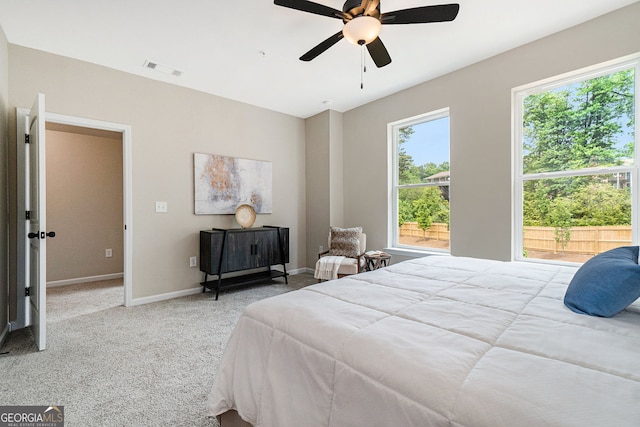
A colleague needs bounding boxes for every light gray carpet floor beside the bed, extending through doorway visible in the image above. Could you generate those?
[0,274,316,427]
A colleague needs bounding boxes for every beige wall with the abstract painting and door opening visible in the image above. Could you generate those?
[9,44,306,308]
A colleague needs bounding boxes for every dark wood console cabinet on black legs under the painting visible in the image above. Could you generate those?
[200,225,289,300]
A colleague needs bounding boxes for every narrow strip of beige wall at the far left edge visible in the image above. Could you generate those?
[0,28,9,344]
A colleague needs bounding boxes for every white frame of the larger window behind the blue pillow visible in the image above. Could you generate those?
[511,53,640,265]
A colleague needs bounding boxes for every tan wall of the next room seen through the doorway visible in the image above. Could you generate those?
[46,123,124,283]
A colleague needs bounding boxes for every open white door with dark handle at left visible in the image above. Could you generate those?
[25,93,55,350]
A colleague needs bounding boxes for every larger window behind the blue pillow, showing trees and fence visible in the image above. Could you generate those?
[514,58,640,263]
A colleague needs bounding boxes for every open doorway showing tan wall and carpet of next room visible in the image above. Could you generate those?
[45,122,124,322]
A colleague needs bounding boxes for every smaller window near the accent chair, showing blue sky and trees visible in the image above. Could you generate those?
[389,109,450,252]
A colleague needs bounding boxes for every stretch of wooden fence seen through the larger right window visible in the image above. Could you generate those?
[523,225,631,255]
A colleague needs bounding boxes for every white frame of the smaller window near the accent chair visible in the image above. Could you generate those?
[387,107,451,256]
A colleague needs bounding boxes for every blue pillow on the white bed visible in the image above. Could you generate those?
[564,246,640,317]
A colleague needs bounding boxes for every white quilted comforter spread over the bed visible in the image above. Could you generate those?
[207,256,640,427]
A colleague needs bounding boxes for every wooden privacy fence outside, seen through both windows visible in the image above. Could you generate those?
[400,222,631,255]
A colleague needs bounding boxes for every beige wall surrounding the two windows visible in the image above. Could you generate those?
[344,3,640,260]
